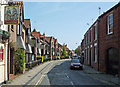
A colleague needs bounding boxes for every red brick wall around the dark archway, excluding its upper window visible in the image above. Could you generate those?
[99,7,120,72]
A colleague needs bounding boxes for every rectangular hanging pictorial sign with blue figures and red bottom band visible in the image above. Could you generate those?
[4,6,20,25]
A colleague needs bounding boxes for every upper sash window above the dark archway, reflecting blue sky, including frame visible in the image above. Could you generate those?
[107,14,113,34]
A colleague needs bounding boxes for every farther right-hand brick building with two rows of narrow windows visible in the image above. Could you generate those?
[82,21,98,69]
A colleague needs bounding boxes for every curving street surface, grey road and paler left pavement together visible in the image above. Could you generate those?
[3,59,120,87]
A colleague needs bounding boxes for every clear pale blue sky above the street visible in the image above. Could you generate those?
[24,2,117,50]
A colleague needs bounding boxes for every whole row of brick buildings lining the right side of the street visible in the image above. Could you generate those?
[81,3,120,76]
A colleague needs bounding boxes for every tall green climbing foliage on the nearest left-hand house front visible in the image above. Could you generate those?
[15,48,25,73]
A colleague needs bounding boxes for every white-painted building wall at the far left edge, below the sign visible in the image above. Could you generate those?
[0,0,8,83]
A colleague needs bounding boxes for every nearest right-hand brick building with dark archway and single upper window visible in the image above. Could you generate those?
[99,3,120,76]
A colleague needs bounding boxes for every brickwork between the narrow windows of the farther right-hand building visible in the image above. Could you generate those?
[84,22,98,70]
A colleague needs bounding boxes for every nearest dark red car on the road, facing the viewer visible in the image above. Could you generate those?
[70,59,83,70]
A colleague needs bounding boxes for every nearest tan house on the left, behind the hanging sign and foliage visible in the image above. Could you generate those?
[8,1,26,77]
